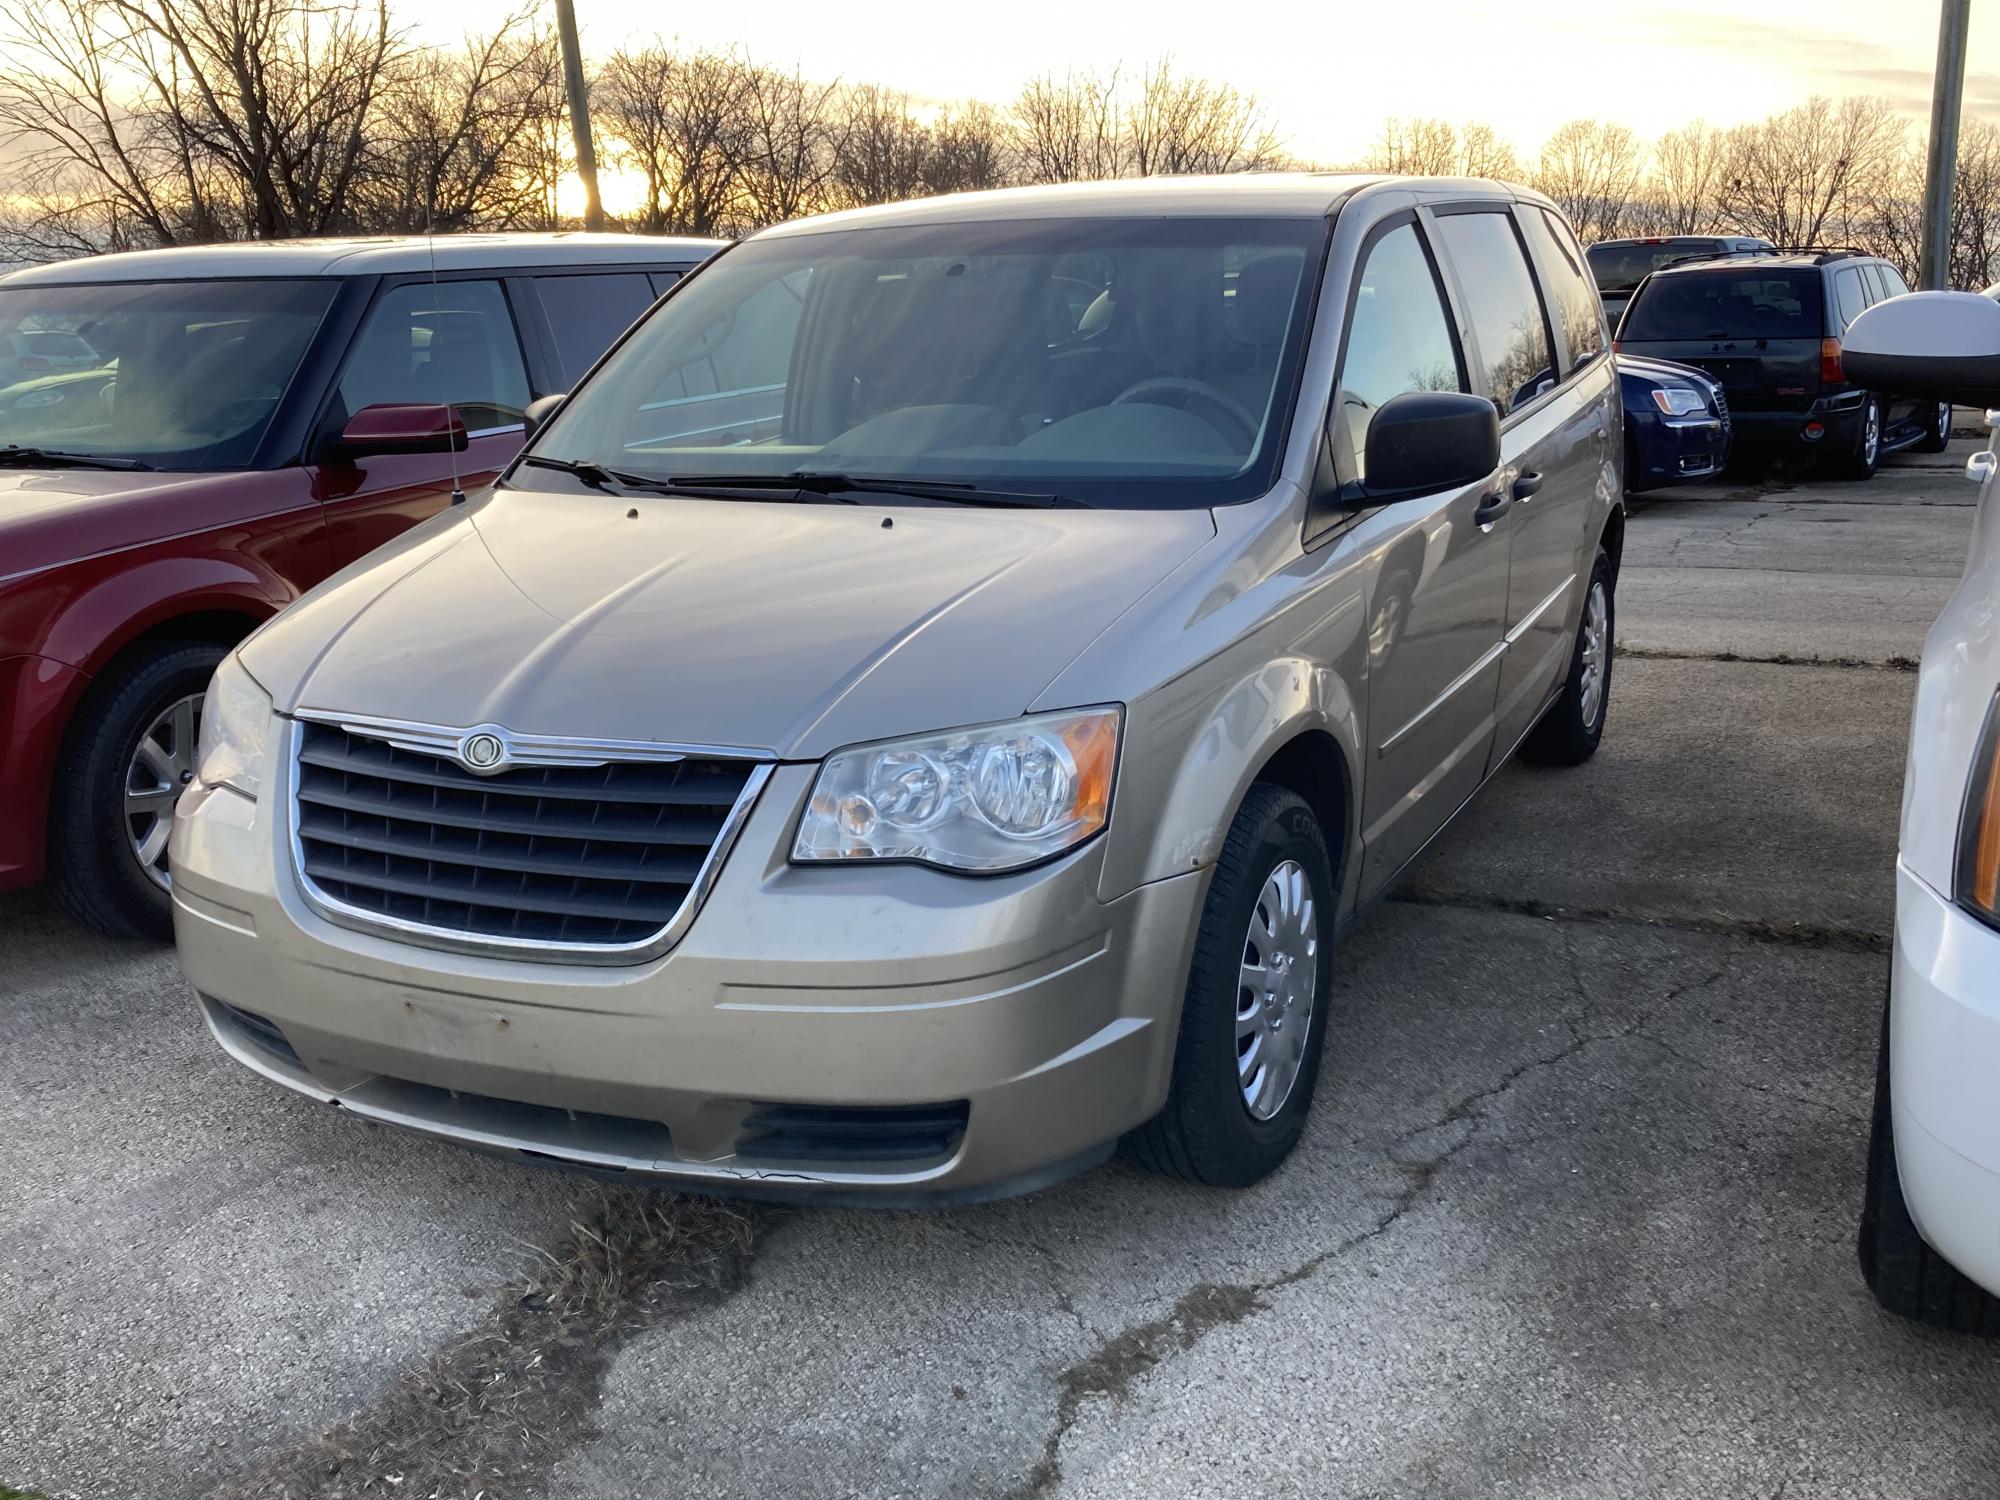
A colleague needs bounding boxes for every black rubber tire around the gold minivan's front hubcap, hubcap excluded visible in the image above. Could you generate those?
[1124,782,1336,1188]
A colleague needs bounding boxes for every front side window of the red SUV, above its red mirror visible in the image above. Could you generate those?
[340,282,528,432]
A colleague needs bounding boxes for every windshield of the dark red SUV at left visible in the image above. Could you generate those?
[0,278,334,470]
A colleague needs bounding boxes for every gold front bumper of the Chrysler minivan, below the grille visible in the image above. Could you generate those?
[172,766,1208,1202]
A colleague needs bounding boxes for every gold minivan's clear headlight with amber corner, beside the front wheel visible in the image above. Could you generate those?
[792,708,1122,870]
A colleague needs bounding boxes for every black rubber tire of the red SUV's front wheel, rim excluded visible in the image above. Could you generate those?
[48,640,226,942]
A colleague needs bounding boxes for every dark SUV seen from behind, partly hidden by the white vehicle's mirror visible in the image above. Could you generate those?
[1616,248,1952,480]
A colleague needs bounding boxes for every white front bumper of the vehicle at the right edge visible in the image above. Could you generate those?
[1888,862,2000,1294]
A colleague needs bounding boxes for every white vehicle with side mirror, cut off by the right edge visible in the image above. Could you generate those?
[1844,292,2000,1334]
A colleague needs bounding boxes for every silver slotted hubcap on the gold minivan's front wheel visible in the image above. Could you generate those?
[1236,860,1320,1120]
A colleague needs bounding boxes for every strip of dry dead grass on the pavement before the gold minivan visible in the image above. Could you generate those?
[209,1188,762,1500]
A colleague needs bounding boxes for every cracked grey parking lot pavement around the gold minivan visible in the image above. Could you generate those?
[0,440,2000,1500]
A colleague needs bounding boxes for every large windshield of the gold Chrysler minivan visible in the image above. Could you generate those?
[528,218,1326,506]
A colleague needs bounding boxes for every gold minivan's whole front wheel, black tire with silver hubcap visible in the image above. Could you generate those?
[1124,782,1336,1188]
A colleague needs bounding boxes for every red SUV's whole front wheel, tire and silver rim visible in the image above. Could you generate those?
[48,640,224,940]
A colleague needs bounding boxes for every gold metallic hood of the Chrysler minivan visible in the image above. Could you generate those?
[244,490,1216,758]
